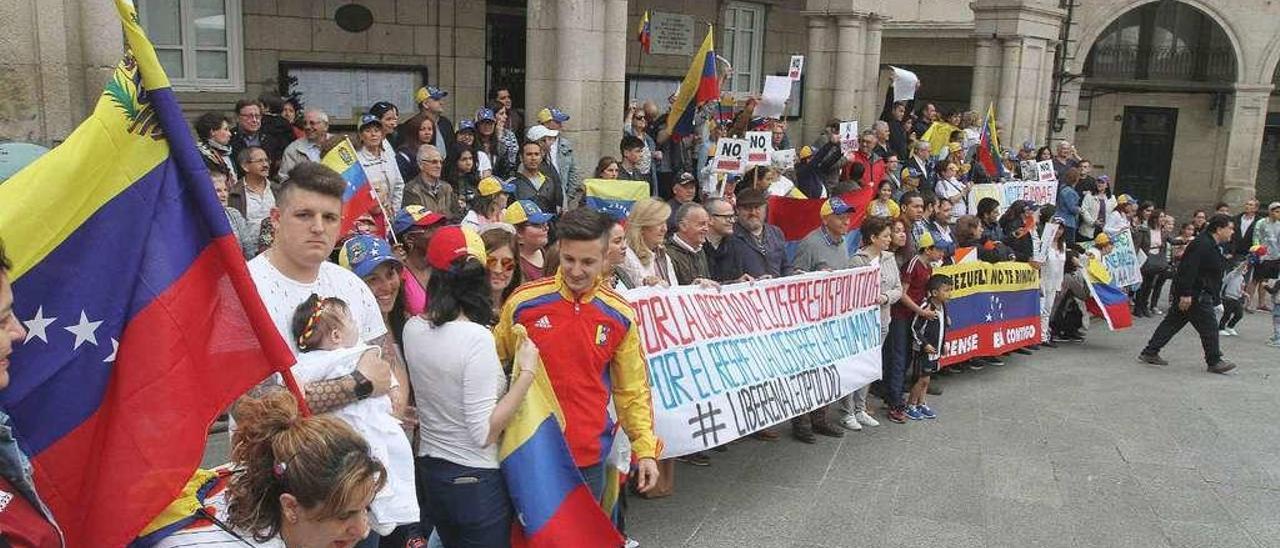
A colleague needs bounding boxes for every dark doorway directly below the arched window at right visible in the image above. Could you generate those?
[1116,106,1178,207]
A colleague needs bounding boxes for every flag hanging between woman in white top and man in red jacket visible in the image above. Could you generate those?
[498,367,622,548]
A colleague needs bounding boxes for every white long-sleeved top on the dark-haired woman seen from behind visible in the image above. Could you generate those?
[404,316,507,470]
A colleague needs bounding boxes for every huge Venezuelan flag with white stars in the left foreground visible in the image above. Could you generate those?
[0,0,293,547]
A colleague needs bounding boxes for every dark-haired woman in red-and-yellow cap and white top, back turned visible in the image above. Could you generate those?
[404,227,539,547]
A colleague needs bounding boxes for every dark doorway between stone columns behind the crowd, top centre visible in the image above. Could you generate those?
[485,0,526,110]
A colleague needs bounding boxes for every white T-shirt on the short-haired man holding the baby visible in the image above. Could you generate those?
[248,252,387,355]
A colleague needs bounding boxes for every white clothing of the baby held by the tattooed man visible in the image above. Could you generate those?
[292,344,421,535]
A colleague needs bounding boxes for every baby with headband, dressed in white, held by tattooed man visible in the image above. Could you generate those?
[289,293,419,535]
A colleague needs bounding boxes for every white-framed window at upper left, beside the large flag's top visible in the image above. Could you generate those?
[138,0,244,91]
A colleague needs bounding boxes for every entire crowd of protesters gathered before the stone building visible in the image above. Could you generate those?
[0,79,1280,547]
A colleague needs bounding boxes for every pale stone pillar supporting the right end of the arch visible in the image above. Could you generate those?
[1220,83,1275,206]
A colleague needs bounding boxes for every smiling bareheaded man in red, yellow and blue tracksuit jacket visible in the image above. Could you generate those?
[494,207,662,499]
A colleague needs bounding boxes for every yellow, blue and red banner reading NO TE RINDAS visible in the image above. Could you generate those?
[933,261,1041,366]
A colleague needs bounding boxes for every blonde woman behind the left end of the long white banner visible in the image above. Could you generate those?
[622,198,676,287]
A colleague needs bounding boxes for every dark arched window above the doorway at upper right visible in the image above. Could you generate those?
[1084,1,1235,82]
